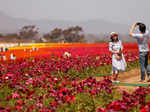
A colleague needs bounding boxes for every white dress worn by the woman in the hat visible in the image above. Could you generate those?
[109,40,127,74]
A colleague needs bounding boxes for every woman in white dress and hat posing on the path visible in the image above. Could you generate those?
[109,32,127,82]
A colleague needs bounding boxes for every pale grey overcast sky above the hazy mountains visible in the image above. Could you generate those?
[0,0,150,24]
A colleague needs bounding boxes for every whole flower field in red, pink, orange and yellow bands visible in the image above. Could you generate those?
[0,44,150,112]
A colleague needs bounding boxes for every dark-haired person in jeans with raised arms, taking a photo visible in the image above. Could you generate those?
[129,22,150,82]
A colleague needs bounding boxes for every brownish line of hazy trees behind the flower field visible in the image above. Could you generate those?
[0,25,86,43]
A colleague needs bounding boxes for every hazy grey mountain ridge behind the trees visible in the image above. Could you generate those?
[0,12,128,34]
